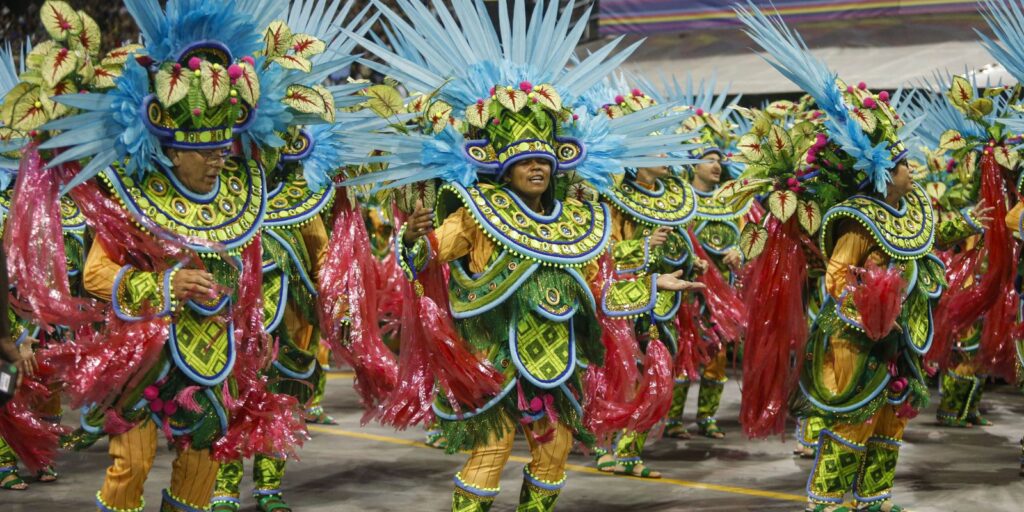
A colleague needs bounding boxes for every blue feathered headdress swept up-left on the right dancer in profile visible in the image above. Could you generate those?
[735,2,906,194]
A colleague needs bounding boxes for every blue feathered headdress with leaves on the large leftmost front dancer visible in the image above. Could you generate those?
[40,0,285,189]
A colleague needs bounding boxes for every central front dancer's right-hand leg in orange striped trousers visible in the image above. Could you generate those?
[516,420,572,512]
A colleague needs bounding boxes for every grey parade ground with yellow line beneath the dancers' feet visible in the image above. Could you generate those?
[8,373,1024,512]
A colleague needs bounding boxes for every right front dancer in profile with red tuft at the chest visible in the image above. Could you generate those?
[737,4,991,512]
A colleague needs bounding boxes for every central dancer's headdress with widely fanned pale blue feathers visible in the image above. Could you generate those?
[339,0,700,192]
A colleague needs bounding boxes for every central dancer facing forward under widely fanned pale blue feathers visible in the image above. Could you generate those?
[337,0,704,511]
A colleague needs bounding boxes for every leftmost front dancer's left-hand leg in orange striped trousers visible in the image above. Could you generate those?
[96,420,157,512]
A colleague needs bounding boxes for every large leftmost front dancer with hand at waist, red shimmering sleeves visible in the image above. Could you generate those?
[3,0,315,511]
